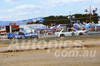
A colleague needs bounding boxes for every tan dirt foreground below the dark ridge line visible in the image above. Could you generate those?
[0,47,100,66]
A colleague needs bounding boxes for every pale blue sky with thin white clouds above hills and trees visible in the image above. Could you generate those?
[0,0,100,21]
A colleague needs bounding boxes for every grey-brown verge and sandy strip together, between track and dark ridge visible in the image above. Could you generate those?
[0,34,100,52]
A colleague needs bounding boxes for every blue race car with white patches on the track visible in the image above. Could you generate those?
[7,32,38,39]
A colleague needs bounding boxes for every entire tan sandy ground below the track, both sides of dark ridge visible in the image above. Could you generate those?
[0,34,100,66]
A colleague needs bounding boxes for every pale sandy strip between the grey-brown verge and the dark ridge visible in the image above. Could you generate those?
[0,39,100,53]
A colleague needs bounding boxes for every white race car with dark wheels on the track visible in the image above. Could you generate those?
[55,28,88,37]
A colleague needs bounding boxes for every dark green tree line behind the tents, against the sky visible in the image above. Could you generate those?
[43,13,98,25]
